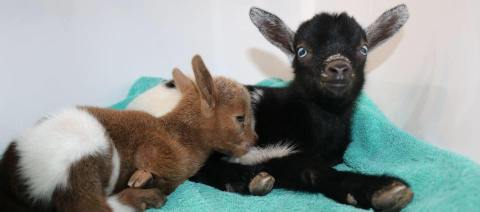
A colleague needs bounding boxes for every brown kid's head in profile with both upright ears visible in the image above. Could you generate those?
[173,55,257,156]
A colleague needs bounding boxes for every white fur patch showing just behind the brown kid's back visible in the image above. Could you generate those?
[127,84,182,117]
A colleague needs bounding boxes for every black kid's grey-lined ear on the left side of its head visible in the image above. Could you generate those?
[250,7,295,59]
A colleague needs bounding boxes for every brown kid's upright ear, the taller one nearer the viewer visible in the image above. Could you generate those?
[192,55,216,112]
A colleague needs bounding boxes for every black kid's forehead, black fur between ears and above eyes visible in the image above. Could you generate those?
[295,13,366,45]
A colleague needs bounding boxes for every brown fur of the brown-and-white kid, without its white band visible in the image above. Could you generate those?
[4,56,257,211]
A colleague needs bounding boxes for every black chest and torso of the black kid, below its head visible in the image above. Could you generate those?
[251,87,351,165]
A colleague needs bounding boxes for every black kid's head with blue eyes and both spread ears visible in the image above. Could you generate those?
[250,5,408,98]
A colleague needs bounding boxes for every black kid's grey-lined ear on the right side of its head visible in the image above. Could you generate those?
[366,4,409,49]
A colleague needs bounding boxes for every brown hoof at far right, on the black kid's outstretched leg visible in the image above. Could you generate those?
[372,181,413,212]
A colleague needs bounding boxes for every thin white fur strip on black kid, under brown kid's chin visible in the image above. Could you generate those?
[226,143,298,165]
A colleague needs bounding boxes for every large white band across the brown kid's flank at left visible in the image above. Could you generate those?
[16,108,110,202]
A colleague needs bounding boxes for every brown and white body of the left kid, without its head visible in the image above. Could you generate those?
[1,108,202,211]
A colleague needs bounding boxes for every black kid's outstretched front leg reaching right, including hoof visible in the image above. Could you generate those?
[261,154,413,211]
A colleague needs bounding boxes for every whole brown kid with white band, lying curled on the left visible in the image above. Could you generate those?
[1,56,257,211]
